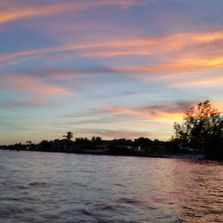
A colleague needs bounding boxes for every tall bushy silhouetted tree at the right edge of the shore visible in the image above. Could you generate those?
[174,101,223,157]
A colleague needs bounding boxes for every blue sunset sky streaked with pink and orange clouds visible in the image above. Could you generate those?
[0,0,223,144]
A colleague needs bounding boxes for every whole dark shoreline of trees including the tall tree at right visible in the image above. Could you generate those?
[0,101,223,160]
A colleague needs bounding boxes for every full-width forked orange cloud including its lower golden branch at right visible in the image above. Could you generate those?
[0,28,223,68]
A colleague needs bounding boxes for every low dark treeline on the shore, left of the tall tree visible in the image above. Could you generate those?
[2,132,177,155]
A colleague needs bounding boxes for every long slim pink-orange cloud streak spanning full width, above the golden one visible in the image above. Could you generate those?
[0,30,223,62]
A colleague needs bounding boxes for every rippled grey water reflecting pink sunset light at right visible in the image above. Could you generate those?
[0,151,223,223]
